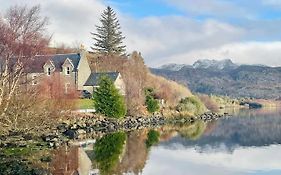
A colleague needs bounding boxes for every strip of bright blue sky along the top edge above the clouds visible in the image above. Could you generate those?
[108,0,281,19]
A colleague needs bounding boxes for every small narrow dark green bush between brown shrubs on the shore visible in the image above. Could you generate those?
[145,88,160,113]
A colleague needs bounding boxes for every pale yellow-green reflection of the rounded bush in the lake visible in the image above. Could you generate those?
[178,121,206,140]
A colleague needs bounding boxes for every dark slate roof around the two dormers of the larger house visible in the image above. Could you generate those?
[27,53,81,73]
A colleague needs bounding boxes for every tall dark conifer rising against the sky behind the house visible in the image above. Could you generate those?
[91,6,126,55]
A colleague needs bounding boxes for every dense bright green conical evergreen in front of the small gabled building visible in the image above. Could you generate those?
[93,75,126,118]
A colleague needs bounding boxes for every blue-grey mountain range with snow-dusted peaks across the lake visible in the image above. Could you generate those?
[151,60,281,99]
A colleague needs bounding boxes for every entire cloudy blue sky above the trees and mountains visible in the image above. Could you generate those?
[0,0,281,67]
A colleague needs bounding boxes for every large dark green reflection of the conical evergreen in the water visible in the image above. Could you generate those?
[94,132,126,174]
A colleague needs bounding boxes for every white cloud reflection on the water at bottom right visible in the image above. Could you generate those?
[143,145,281,175]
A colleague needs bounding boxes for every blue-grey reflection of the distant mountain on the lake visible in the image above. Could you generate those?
[162,110,281,151]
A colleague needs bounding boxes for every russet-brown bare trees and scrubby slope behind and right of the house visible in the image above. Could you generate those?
[88,52,192,116]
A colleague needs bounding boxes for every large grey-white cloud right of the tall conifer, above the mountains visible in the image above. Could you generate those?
[121,16,245,65]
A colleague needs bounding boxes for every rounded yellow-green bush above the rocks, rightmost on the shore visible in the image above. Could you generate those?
[176,96,206,114]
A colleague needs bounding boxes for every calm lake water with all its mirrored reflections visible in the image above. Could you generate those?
[49,109,281,175]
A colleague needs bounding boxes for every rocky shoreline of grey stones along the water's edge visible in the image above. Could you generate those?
[0,112,228,148]
